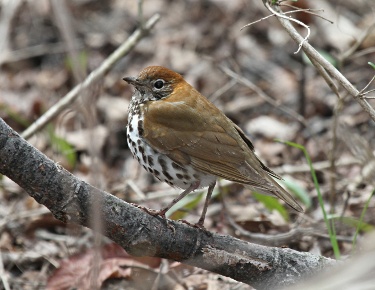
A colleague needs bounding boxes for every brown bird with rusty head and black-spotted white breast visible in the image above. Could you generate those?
[123,66,303,228]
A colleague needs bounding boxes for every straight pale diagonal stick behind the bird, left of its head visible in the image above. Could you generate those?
[22,14,160,139]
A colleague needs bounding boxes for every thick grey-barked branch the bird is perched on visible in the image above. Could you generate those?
[0,118,335,289]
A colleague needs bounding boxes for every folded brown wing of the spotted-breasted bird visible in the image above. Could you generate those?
[144,89,272,187]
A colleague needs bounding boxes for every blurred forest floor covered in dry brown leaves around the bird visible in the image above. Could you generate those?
[0,0,375,289]
